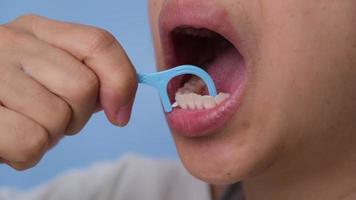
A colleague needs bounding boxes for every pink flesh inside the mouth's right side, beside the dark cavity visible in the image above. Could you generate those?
[206,47,245,93]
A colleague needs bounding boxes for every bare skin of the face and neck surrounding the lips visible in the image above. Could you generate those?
[149,0,356,200]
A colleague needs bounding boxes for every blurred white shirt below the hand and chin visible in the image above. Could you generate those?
[0,156,211,200]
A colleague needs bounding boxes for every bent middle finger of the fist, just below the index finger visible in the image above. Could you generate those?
[14,31,99,134]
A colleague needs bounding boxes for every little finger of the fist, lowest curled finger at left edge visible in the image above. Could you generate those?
[0,106,48,168]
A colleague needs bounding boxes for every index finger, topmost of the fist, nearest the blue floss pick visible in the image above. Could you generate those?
[9,16,137,125]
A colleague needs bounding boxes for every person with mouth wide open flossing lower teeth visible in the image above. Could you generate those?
[0,0,356,200]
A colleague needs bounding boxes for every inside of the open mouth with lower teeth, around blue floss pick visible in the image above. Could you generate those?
[169,26,242,110]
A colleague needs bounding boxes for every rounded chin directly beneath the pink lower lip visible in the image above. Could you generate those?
[173,122,282,185]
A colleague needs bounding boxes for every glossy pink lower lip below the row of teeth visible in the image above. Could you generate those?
[167,47,246,138]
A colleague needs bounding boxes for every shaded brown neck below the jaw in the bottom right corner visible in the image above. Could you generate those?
[244,130,356,200]
